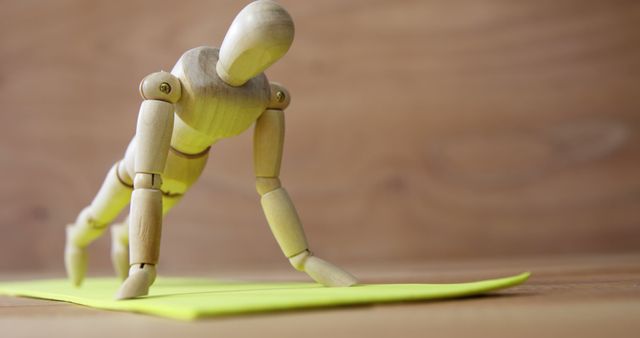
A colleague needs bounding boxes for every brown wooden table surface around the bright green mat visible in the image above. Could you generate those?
[0,254,640,338]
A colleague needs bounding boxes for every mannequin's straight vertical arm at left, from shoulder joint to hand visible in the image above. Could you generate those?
[116,72,181,299]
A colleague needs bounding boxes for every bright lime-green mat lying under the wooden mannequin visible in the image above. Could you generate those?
[0,272,529,320]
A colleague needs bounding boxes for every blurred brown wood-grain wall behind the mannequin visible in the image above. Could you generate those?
[0,0,640,273]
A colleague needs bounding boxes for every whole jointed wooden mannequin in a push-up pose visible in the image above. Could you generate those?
[65,0,357,299]
